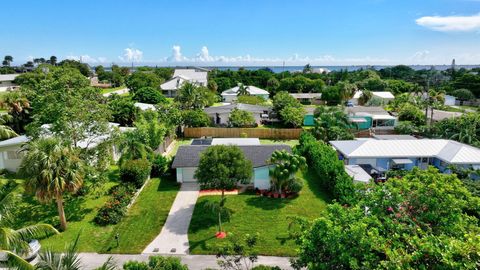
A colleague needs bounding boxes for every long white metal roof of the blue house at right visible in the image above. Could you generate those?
[330,139,480,164]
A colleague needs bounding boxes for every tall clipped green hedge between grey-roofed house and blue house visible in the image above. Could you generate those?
[297,132,355,204]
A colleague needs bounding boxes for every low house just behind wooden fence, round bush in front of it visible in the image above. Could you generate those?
[203,103,272,125]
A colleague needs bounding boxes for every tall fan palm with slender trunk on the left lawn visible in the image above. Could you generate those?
[19,137,84,230]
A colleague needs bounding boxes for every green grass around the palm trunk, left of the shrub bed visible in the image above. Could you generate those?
[16,169,118,252]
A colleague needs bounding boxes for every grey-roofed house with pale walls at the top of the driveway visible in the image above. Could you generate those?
[172,138,292,189]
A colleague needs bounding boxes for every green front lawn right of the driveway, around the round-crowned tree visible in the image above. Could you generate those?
[189,172,330,256]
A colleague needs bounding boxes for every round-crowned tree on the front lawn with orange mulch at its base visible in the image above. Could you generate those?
[195,145,253,237]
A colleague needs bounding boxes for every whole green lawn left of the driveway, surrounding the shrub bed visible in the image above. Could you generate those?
[7,167,178,253]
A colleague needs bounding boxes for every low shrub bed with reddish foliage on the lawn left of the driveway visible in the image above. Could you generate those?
[94,185,135,226]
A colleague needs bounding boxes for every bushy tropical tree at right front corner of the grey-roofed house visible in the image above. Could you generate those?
[269,150,307,193]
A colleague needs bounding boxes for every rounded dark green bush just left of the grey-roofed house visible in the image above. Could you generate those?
[120,159,152,188]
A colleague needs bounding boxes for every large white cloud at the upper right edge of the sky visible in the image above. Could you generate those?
[415,13,480,32]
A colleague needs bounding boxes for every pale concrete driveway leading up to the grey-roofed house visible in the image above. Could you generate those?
[143,183,199,255]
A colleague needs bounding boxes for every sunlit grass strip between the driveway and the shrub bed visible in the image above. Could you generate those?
[102,178,179,254]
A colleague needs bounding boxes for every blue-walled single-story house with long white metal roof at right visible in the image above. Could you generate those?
[330,139,480,176]
